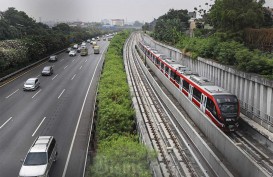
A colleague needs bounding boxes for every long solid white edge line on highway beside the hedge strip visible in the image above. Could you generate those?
[62,46,104,177]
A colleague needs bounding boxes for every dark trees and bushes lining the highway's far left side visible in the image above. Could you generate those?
[0,8,102,77]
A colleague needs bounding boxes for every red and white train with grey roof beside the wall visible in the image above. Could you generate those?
[139,41,240,132]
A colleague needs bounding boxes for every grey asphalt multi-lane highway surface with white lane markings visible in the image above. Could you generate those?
[0,41,108,177]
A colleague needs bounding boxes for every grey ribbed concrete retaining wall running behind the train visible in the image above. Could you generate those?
[143,36,273,132]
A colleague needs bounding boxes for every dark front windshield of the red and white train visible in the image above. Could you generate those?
[214,95,238,114]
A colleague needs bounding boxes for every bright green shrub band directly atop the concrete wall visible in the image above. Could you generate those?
[176,33,273,79]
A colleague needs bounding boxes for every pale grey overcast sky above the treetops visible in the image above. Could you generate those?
[0,0,273,22]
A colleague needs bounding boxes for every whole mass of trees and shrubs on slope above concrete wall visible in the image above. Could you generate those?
[143,0,273,79]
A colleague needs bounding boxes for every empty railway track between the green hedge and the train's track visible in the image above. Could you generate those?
[123,32,206,177]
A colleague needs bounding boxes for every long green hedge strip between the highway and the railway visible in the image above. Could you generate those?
[89,32,153,177]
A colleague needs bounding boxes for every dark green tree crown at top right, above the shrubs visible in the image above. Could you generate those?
[208,0,264,32]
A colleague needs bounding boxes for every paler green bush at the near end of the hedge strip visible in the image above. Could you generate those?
[89,136,155,177]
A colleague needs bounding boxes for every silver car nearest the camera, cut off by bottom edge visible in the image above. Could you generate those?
[19,136,58,177]
